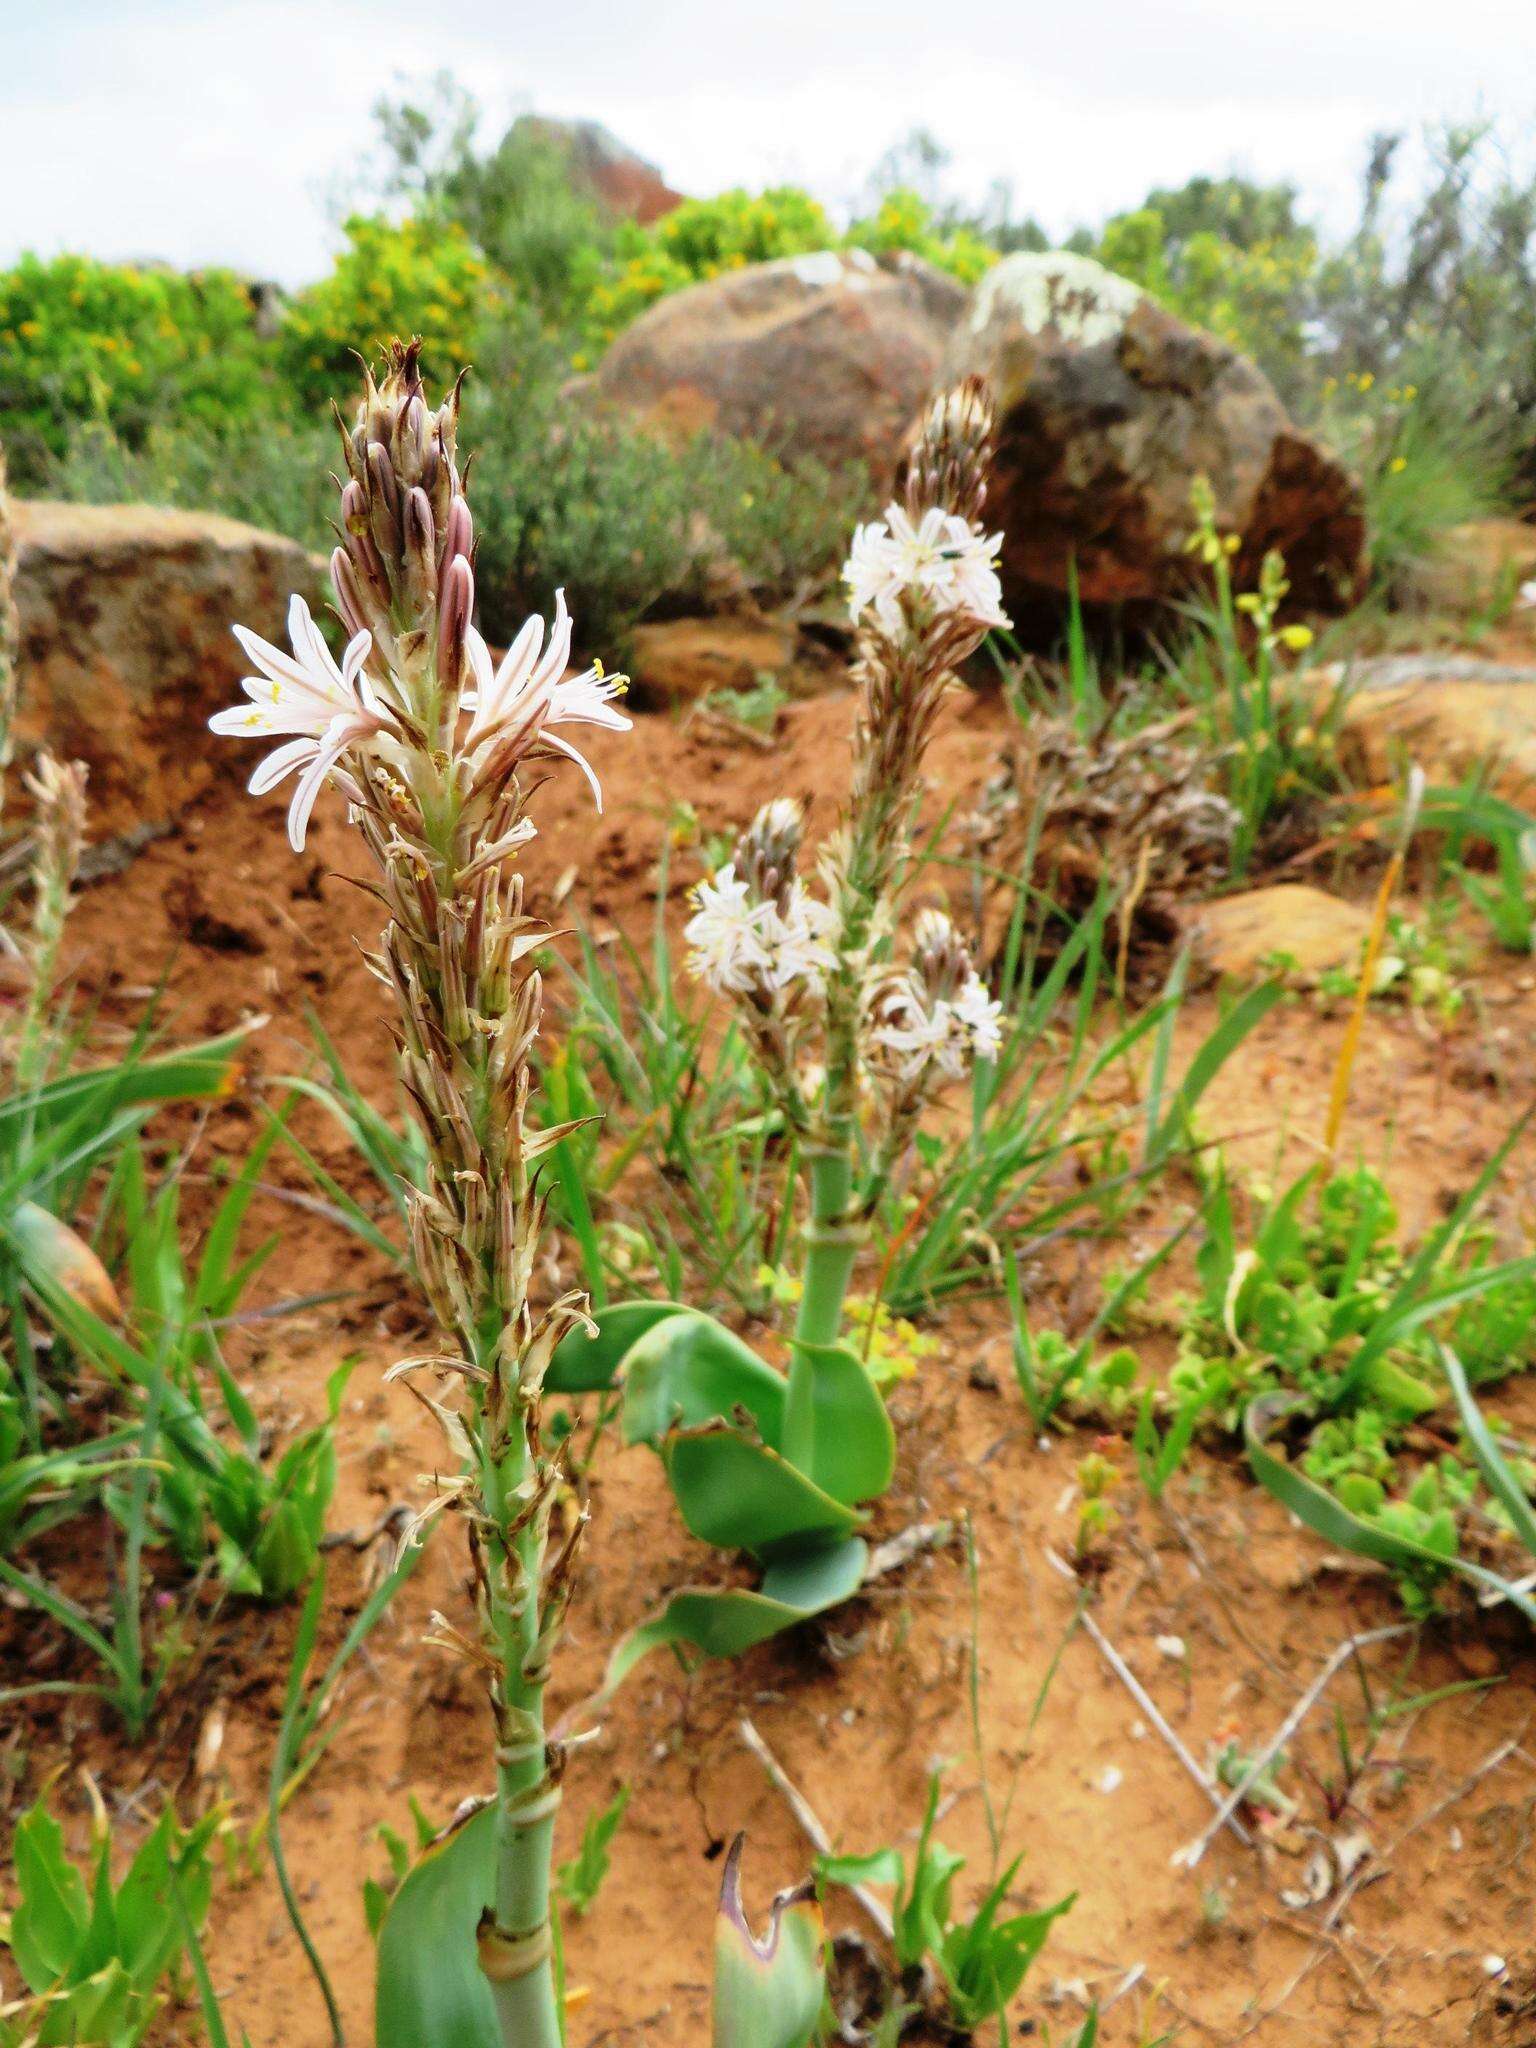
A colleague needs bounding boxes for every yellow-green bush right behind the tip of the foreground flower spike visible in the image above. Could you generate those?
[279,213,510,408]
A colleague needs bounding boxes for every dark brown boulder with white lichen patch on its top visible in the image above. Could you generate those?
[942,254,1364,627]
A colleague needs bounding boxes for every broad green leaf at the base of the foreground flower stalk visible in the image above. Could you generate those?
[373,1806,502,2048]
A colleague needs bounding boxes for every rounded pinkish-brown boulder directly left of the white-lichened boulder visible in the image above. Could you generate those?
[596,250,965,487]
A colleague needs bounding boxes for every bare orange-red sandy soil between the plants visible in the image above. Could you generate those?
[0,675,1536,2048]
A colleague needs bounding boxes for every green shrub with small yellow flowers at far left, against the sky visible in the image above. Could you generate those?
[0,256,266,487]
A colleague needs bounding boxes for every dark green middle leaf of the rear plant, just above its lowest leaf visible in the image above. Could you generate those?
[662,1423,858,1556]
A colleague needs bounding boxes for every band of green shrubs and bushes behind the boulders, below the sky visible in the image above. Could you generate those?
[0,76,1536,643]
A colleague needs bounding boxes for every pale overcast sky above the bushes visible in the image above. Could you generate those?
[0,0,1536,283]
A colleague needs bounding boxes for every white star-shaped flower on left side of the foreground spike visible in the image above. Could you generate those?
[209,596,393,852]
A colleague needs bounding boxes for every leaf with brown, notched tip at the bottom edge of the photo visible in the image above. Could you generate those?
[713,1835,825,2048]
